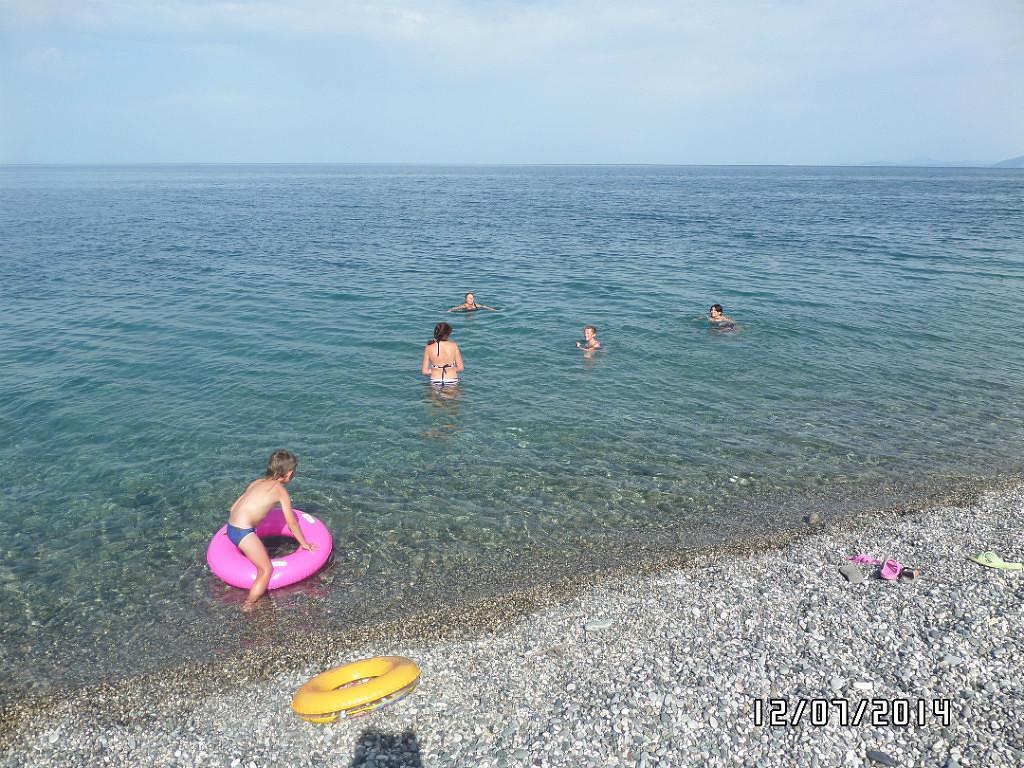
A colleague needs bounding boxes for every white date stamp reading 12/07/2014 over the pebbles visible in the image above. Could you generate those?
[754,698,952,727]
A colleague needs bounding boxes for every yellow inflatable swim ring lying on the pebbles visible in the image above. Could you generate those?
[292,656,420,723]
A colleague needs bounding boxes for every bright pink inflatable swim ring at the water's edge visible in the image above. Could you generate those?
[206,507,334,590]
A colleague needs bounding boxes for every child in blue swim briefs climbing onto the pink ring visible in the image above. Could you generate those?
[227,451,316,611]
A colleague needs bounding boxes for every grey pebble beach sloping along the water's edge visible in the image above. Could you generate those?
[0,485,1024,768]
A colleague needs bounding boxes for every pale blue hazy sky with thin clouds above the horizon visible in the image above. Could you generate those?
[0,0,1024,165]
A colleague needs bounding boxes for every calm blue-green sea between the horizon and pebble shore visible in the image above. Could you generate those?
[0,166,1024,697]
